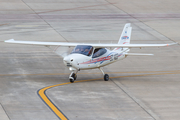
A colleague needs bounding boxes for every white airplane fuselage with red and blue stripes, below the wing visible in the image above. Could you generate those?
[63,45,129,70]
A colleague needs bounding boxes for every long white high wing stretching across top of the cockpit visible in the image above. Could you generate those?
[4,39,177,48]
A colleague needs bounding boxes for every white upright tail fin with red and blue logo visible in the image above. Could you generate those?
[118,23,132,44]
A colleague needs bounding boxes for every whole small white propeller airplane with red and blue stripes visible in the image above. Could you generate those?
[5,23,177,83]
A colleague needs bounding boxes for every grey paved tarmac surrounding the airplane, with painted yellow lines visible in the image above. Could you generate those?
[0,0,180,120]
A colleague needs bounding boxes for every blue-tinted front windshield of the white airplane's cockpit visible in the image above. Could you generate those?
[71,45,93,56]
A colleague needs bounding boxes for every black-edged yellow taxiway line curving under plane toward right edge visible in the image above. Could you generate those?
[38,70,180,120]
